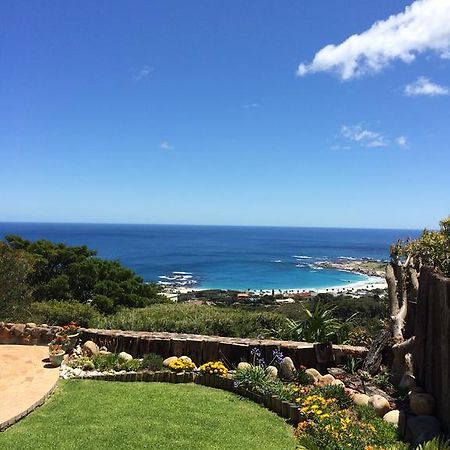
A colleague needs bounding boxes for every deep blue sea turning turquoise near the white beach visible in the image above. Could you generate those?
[0,223,420,289]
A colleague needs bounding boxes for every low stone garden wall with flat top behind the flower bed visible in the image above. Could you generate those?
[0,323,367,369]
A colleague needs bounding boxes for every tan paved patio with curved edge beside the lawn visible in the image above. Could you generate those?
[0,345,59,430]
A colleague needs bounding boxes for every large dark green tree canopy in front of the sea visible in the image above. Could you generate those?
[2,235,163,313]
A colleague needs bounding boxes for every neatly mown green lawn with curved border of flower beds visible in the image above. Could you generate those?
[0,380,295,450]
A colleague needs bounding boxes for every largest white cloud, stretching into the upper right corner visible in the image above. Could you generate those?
[297,0,450,80]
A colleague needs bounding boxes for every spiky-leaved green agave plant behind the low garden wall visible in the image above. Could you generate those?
[287,302,356,344]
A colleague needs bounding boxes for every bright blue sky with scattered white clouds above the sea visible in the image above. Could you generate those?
[0,0,450,228]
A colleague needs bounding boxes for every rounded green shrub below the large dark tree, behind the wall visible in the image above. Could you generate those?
[30,300,100,327]
